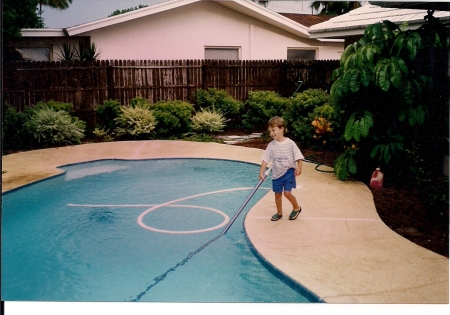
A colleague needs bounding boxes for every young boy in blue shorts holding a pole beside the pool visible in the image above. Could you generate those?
[259,116,304,221]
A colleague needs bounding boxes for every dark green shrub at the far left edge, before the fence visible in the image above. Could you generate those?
[2,103,30,151]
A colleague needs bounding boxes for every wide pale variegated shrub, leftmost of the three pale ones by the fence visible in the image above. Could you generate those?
[25,107,86,145]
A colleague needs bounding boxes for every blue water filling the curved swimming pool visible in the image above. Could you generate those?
[1,159,318,302]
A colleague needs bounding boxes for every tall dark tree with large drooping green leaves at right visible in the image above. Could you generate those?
[331,16,449,185]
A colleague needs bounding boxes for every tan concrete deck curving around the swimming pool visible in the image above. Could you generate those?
[2,140,449,304]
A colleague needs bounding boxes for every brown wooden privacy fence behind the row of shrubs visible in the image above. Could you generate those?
[3,60,339,126]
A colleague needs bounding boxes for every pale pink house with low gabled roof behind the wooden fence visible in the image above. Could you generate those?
[10,0,344,60]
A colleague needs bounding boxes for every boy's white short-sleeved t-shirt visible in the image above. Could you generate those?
[261,138,304,179]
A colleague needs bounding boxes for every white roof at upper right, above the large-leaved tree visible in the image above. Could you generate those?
[309,4,450,38]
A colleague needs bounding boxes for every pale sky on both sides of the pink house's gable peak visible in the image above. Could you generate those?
[42,0,311,28]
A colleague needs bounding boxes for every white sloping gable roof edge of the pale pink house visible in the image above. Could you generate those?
[65,0,309,38]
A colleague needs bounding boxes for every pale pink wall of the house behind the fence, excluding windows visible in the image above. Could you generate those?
[80,1,343,60]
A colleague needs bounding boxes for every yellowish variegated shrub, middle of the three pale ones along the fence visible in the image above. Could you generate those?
[115,106,157,139]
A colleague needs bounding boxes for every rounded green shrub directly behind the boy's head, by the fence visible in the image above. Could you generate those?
[242,91,290,130]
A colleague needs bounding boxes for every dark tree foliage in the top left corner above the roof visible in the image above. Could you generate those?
[2,0,44,43]
